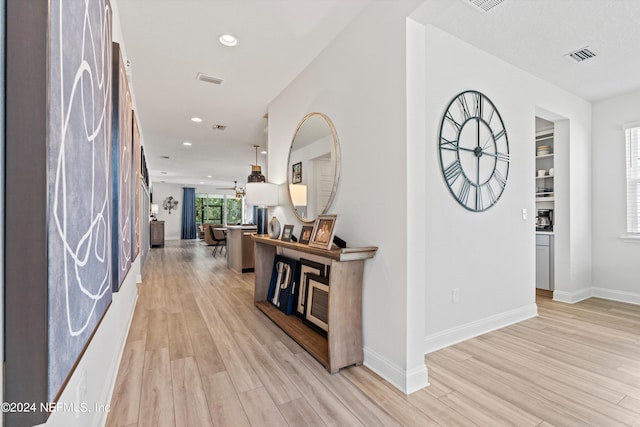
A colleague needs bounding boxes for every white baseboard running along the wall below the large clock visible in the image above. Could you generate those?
[424,304,538,354]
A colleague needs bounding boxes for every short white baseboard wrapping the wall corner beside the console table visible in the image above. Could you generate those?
[364,347,429,394]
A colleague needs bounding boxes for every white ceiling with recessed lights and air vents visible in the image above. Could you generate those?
[117,0,640,191]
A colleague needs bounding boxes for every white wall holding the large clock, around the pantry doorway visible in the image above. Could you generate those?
[408,21,591,352]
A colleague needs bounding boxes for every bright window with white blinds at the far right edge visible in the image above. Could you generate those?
[625,123,640,233]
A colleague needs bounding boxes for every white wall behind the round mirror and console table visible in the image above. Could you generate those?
[268,1,427,391]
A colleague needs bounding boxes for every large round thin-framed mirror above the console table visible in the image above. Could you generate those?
[287,113,340,222]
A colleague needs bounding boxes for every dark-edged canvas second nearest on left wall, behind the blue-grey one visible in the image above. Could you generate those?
[112,43,133,292]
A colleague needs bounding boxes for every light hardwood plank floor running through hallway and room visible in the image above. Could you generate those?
[107,241,640,427]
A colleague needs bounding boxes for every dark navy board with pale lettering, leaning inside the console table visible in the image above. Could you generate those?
[267,255,299,314]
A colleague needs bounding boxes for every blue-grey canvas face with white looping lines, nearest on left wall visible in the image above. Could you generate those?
[48,0,112,402]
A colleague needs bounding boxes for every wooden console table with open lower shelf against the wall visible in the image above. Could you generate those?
[252,235,378,374]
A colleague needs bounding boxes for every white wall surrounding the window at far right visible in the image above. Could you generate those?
[592,91,640,304]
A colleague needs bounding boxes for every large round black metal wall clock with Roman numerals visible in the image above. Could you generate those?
[438,90,509,212]
